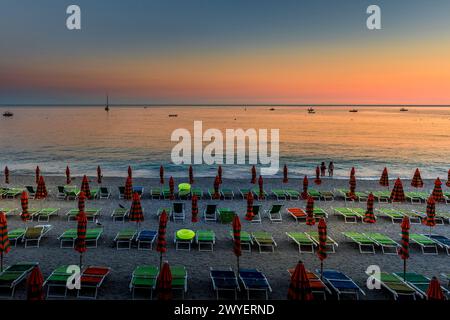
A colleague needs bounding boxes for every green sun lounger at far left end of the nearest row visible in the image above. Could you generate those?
[0,262,38,299]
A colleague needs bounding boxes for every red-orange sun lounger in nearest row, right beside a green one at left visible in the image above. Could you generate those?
[77,266,111,299]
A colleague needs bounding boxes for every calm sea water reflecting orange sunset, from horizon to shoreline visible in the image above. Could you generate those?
[0,107,450,178]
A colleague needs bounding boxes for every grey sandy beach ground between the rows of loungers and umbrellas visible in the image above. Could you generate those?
[0,175,450,299]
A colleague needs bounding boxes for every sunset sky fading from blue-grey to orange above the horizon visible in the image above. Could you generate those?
[0,0,450,105]
